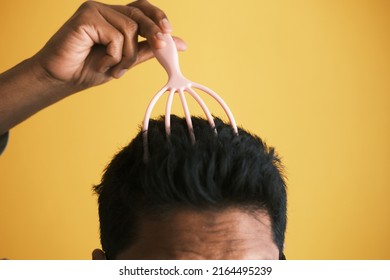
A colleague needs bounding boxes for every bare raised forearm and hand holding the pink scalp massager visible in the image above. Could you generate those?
[0,0,186,135]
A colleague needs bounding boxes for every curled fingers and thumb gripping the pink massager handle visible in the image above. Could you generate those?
[76,0,186,78]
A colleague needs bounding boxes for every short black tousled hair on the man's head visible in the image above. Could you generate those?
[94,115,287,258]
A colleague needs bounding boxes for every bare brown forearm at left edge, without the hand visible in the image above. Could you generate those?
[0,58,73,135]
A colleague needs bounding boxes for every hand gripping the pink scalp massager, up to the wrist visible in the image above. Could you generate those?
[33,0,186,91]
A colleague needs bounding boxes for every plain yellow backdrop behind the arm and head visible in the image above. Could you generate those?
[0,0,390,259]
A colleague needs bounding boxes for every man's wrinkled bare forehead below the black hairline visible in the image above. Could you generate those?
[118,208,279,259]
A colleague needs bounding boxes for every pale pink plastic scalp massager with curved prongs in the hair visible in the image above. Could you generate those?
[142,34,238,162]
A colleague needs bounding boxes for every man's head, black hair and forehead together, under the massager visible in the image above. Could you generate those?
[95,116,286,259]
